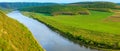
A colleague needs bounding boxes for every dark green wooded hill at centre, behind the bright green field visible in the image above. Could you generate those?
[20,5,90,15]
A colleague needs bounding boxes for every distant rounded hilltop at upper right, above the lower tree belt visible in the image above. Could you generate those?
[69,2,117,8]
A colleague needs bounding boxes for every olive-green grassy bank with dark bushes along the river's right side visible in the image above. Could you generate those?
[23,12,119,51]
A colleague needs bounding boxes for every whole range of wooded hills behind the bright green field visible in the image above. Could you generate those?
[20,2,117,15]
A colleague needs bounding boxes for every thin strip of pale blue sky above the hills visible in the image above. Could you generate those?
[0,0,120,3]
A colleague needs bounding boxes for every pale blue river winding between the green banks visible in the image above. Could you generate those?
[7,11,98,51]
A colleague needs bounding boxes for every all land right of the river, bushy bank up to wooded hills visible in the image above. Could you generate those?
[17,2,120,51]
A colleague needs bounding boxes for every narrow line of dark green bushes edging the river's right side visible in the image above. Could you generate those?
[23,13,119,51]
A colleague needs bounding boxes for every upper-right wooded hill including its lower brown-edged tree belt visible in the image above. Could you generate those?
[67,1,119,12]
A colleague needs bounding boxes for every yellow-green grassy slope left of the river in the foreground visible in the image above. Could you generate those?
[0,11,43,51]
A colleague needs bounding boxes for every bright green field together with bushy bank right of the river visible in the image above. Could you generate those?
[23,11,120,49]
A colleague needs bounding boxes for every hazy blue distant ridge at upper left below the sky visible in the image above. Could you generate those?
[0,2,57,9]
